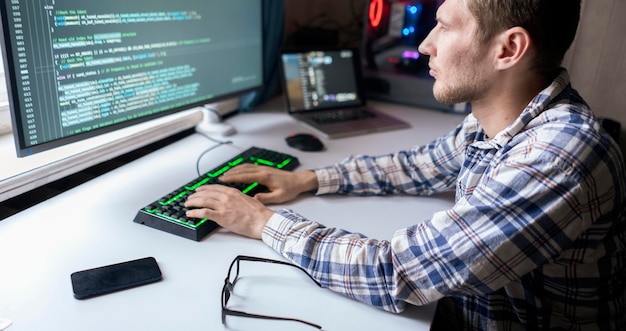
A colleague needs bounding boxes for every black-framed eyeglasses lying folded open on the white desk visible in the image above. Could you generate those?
[222,255,322,330]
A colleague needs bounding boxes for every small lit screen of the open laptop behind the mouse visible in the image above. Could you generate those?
[281,49,365,113]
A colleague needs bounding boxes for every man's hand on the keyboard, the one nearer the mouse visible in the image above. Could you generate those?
[219,163,318,204]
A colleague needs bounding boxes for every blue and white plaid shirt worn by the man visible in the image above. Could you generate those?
[263,70,626,330]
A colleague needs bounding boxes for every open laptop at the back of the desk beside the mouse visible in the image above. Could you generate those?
[280,48,409,139]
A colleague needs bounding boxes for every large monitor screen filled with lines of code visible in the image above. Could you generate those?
[0,0,263,157]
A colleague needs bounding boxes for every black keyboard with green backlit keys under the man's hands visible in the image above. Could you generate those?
[134,147,300,241]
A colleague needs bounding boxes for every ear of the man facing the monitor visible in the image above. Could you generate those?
[495,27,532,70]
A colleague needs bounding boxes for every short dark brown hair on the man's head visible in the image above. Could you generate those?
[465,0,581,75]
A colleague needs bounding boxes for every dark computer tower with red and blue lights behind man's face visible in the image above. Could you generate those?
[361,0,469,113]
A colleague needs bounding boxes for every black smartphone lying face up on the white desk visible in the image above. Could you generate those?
[71,257,162,299]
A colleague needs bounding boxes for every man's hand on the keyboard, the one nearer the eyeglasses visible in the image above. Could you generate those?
[185,184,274,239]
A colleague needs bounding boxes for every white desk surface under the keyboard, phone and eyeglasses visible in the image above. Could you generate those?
[0,100,462,331]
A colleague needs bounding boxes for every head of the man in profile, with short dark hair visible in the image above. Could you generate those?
[419,0,581,104]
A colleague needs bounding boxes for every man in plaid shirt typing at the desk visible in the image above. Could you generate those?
[187,0,626,330]
